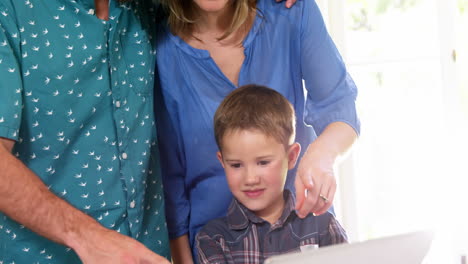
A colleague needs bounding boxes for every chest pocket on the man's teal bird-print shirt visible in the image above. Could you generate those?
[121,30,155,96]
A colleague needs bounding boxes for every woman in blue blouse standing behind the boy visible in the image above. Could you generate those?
[156,0,360,263]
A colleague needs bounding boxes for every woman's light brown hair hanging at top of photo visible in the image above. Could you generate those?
[160,0,257,40]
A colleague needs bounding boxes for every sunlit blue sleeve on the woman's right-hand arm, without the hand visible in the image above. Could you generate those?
[300,0,360,135]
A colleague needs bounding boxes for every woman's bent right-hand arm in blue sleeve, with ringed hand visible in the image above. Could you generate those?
[295,0,360,217]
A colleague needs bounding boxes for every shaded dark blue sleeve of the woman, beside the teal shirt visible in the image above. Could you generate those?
[155,66,190,239]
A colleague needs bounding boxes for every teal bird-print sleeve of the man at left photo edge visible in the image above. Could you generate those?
[0,1,23,140]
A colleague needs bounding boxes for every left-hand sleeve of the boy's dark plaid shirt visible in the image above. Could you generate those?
[195,230,229,264]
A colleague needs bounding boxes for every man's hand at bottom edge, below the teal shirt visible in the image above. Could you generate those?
[69,227,170,264]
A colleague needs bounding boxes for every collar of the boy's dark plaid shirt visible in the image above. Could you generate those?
[227,189,296,230]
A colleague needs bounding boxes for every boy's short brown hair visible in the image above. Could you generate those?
[214,85,296,150]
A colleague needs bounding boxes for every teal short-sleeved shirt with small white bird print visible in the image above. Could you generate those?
[0,0,169,264]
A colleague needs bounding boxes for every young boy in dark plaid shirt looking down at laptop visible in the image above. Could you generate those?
[196,85,347,264]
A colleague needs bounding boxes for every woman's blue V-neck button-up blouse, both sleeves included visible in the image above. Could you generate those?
[156,0,359,250]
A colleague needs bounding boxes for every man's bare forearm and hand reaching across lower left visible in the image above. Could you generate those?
[0,138,169,263]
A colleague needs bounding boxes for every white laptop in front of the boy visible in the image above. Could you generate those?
[265,231,433,264]
